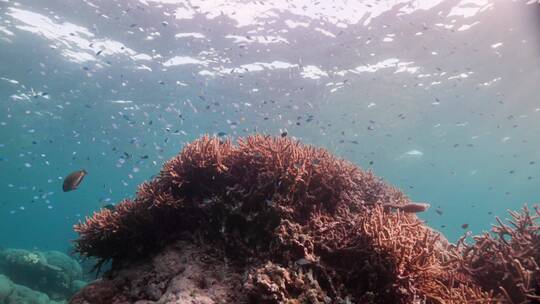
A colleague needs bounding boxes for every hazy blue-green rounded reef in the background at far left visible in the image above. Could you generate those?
[0,248,85,303]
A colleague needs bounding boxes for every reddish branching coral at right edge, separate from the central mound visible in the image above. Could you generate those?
[458,206,540,303]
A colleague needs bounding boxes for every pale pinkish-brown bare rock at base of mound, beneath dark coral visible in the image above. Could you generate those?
[70,242,246,304]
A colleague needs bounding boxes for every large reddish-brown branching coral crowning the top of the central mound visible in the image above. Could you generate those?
[75,135,408,259]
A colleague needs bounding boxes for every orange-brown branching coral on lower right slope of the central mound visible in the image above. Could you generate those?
[296,205,495,303]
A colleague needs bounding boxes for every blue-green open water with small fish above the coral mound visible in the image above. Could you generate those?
[0,0,540,251]
